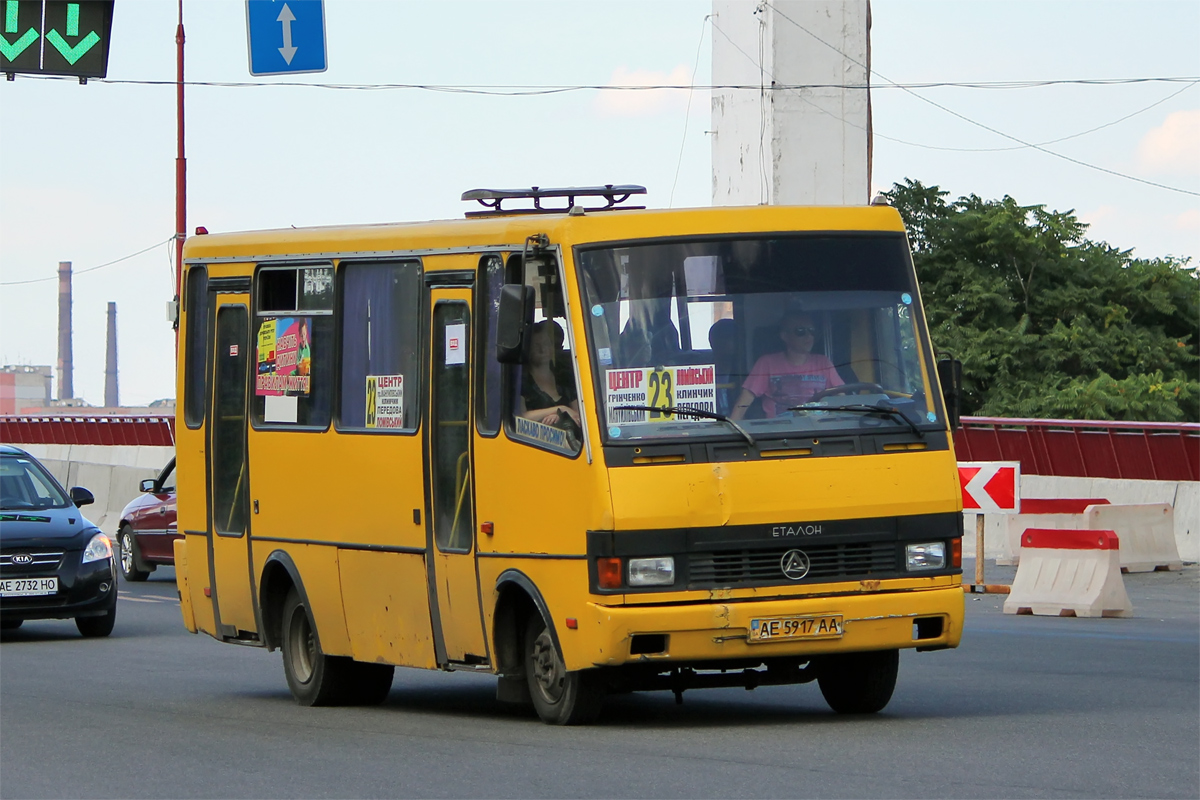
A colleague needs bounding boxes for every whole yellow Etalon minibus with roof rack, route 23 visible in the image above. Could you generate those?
[175,186,964,724]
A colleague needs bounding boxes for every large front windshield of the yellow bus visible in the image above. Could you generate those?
[576,233,943,444]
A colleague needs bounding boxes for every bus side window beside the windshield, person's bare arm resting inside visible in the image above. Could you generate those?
[505,255,583,456]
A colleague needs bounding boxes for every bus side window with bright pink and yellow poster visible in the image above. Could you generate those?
[250,264,334,429]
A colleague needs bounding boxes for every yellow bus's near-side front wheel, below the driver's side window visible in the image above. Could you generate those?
[522,613,605,724]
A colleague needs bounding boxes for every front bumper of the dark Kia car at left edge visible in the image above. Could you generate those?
[0,553,116,620]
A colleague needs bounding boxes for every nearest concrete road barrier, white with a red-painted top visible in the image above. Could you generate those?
[1004,528,1133,616]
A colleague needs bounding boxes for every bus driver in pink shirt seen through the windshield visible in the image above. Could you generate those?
[730,312,844,420]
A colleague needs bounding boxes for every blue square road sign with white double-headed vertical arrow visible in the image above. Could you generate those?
[246,0,329,76]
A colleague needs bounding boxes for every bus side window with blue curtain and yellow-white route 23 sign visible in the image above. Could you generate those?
[337,260,421,432]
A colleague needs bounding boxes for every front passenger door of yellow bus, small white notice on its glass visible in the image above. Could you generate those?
[426,288,487,664]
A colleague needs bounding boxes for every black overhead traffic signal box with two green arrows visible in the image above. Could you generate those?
[0,0,114,78]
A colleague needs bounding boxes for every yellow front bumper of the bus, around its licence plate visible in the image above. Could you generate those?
[576,585,964,669]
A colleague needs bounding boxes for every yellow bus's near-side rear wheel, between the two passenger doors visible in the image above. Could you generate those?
[280,587,350,705]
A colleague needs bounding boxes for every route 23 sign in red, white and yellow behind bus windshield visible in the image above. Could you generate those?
[604,363,716,426]
